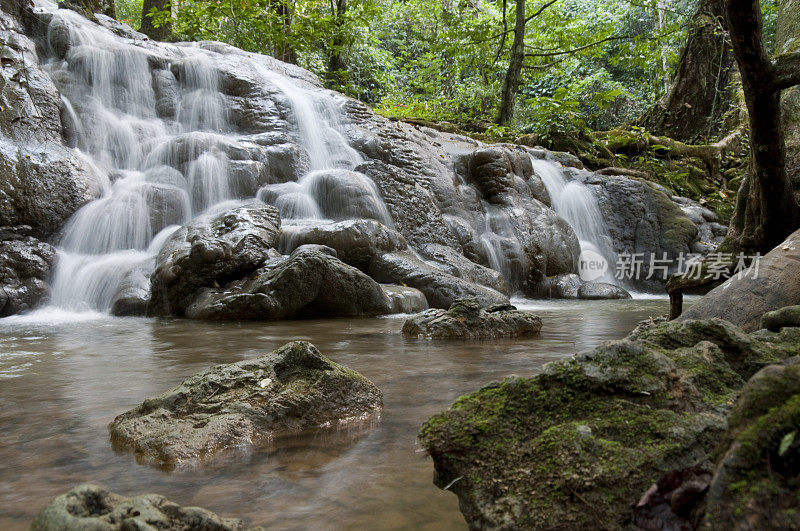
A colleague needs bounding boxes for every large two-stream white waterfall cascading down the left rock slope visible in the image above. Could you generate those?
[36,4,392,315]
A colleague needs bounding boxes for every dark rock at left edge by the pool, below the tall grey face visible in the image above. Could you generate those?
[0,226,56,317]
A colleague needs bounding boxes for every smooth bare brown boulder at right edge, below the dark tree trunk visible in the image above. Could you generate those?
[679,231,800,330]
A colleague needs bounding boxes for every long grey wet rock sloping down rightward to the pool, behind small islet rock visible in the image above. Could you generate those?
[370,251,508,308]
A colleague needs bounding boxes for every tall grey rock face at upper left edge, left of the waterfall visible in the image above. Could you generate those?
[0,11,101,238]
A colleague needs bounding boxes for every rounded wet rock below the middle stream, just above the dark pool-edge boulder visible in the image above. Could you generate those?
[279,219,408,271]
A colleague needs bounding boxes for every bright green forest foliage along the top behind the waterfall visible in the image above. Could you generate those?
[117,0,777,136]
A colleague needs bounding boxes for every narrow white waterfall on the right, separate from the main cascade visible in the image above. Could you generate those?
[531,157,618,284]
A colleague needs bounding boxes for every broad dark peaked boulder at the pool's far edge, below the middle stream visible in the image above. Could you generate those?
[186,245,392,321]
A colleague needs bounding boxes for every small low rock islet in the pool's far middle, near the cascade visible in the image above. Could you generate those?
[403,299,542,339]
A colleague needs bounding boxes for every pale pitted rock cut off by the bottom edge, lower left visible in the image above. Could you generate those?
[31,485,261,531]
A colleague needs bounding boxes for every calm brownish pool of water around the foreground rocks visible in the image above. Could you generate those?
[0,299,684,530]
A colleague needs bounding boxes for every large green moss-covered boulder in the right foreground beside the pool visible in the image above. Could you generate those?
[420,319,800,529]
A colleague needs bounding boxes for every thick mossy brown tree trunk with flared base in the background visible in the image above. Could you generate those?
[640,0,738,143]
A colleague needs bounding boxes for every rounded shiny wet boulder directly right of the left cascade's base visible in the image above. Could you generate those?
[150,201,280,315]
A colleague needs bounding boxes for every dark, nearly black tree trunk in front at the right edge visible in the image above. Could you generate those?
[726,0,800,252]
